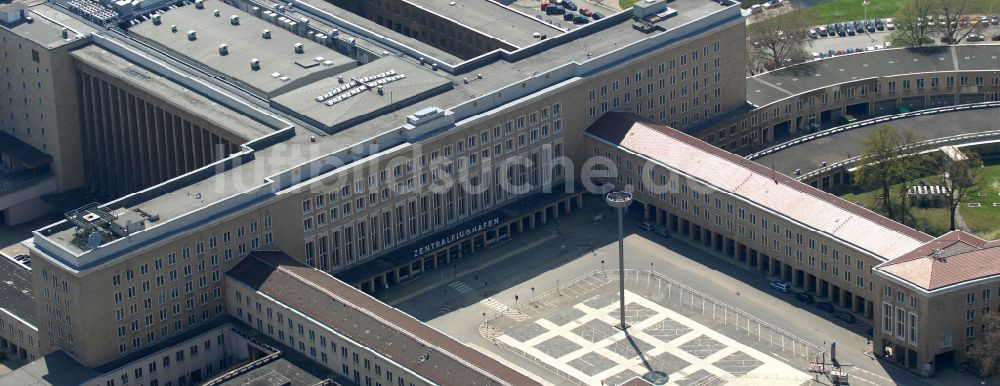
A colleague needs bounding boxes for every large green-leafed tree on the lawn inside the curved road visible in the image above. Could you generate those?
[855,125,916,219]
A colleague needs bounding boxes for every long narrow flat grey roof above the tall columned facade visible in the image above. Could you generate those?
[70,44,274,141]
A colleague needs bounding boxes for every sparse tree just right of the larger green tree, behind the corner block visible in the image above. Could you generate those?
[935,152,983,230]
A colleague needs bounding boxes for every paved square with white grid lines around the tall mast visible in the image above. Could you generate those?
[496,290,810,386]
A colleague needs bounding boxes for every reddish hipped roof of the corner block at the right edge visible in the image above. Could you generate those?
[875,231,1000,291]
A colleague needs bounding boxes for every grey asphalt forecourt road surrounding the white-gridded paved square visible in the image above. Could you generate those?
[383,198,944,385]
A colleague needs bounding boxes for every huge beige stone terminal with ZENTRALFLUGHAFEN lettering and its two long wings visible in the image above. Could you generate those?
[0,0,1000,386]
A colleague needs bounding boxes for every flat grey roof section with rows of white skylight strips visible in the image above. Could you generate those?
[271,56,451,131]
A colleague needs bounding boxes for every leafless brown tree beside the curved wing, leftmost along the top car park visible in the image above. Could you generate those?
[747,9,813,75]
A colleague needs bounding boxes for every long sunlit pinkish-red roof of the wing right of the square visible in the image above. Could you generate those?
[586,113,932,260]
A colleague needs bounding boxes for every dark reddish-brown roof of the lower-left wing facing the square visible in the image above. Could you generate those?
[226,252,539,386]
